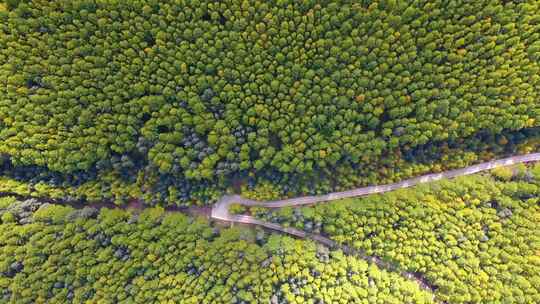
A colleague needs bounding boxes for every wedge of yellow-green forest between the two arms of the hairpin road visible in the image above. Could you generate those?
[252,164,540,304]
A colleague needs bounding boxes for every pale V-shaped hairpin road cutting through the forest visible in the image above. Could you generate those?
[211,153,540,303]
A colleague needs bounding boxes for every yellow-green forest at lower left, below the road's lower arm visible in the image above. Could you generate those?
[0,198,432,304]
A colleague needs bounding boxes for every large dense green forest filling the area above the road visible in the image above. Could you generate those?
[0,0,540,206]
